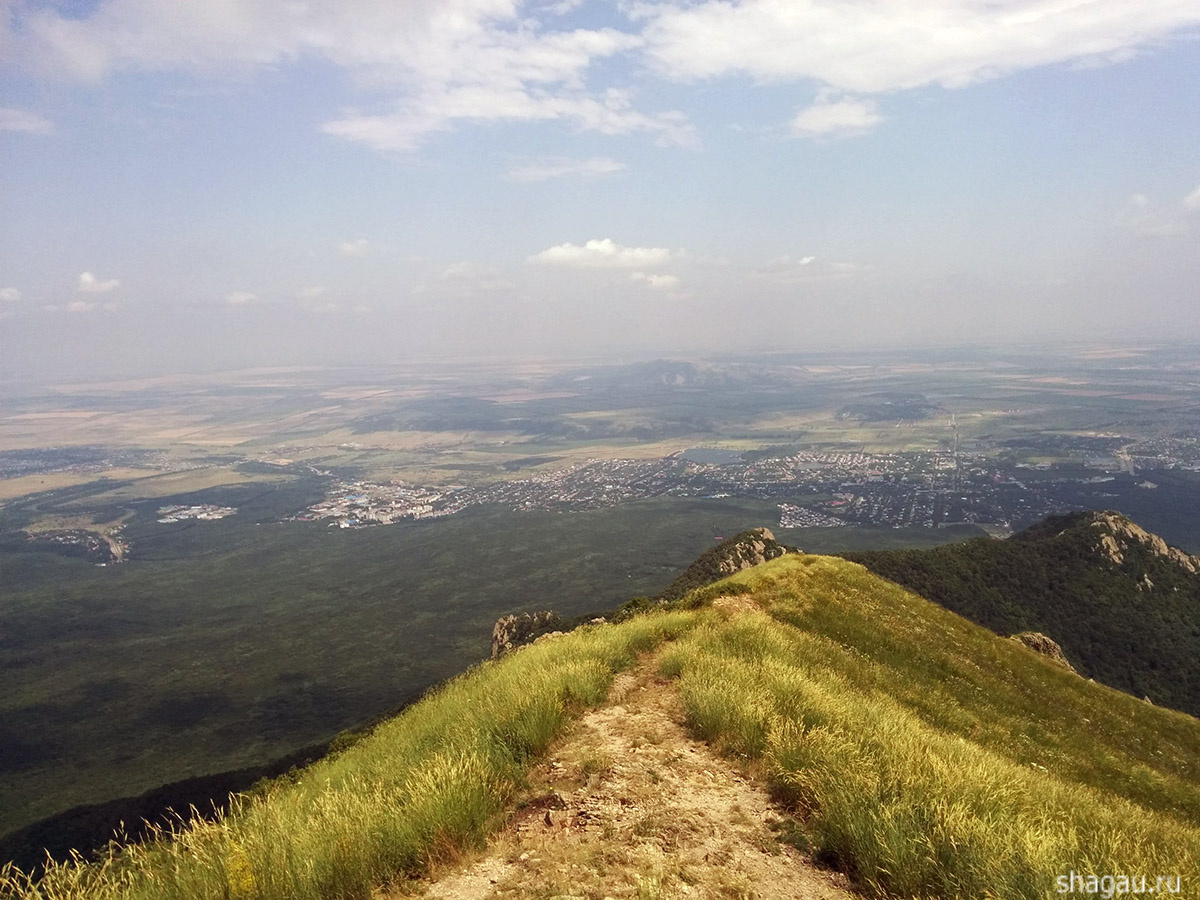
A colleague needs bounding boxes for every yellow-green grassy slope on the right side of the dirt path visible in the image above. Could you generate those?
[660,557,1200,899]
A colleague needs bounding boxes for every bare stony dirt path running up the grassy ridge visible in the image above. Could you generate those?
[408,660,853,900]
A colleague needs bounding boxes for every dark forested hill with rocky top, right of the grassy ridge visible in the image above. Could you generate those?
[845,512,1200,715]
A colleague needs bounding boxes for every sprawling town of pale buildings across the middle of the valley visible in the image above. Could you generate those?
[278,442,1200,528]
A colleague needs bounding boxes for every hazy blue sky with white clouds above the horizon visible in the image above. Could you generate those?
[0,0,1200,382]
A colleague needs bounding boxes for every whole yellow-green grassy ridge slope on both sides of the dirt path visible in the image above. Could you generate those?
[9,553,1200,900]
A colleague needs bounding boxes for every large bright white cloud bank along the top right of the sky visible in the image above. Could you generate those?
[634,0,1200,94]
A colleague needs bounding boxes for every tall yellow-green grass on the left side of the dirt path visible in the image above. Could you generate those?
[0,613,694,900]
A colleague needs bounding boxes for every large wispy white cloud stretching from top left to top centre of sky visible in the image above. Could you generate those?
[20,0,694,151]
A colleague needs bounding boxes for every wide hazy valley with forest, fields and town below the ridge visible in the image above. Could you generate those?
[0,349,1200,868]
